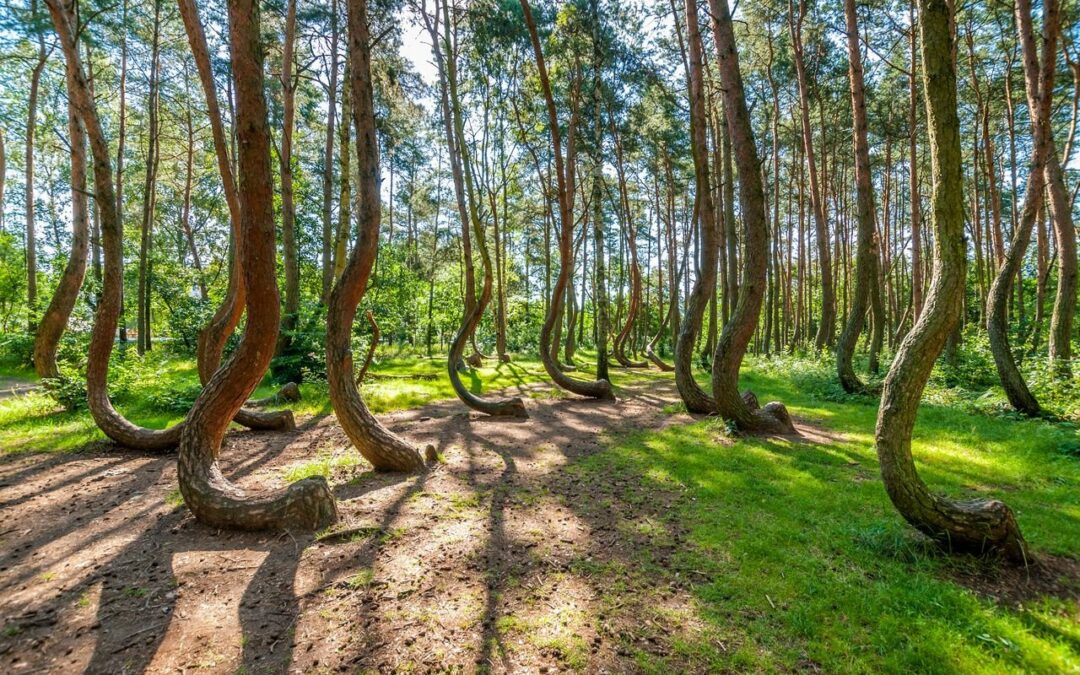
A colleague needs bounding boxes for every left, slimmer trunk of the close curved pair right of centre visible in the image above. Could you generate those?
[675,0,719,414]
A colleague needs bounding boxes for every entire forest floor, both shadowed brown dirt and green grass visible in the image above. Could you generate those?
[0,356,1080,673]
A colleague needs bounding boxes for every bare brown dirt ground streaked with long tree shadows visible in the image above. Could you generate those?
[0,375,717,673]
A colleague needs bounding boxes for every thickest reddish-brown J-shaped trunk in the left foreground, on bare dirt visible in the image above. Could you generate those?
[177,0,337,529]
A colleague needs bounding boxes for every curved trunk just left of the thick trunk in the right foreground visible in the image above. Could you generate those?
[836,0,879,393]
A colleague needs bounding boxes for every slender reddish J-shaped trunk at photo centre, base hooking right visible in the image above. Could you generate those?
[521,0,615,399]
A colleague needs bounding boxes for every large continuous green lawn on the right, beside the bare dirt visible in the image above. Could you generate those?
[570,362,1080,673]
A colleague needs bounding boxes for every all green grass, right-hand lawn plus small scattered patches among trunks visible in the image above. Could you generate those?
[0,353,1080,673]
